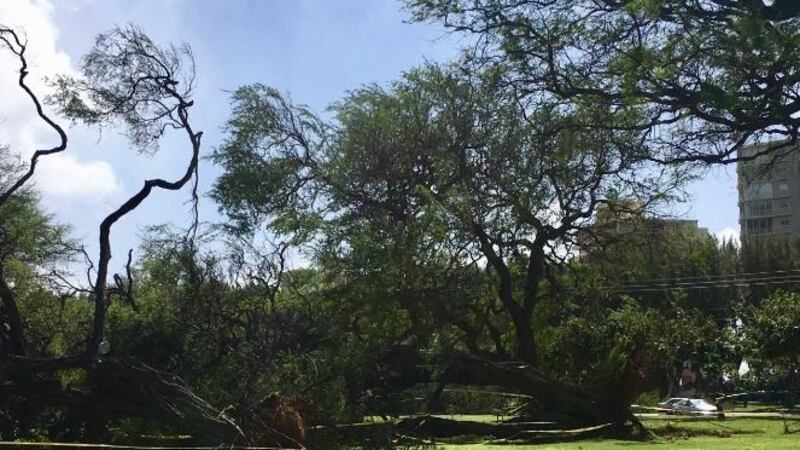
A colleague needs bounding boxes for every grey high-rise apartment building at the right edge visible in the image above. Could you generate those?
[737,145,800,243]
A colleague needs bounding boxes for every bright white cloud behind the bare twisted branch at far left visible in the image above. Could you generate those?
[0,0,119,198]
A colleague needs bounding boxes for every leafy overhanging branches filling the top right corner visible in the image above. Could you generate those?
[407,0,800,164]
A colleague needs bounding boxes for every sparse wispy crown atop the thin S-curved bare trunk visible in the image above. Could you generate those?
[47,24,195,152]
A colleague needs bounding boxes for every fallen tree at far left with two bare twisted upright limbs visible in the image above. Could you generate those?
[0,25,241,443]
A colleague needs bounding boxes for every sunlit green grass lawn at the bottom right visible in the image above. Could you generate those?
[438,418,800,450]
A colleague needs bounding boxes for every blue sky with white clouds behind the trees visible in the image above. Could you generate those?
[0,0,739,276]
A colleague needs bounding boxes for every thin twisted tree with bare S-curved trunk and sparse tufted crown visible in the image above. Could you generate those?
[51,26,203,360]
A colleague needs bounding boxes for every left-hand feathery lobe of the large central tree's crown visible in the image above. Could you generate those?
[212,84,327,240]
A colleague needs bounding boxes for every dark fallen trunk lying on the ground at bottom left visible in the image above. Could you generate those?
[0,357,316,448]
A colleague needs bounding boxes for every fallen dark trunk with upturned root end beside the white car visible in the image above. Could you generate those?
[346,353,645,438]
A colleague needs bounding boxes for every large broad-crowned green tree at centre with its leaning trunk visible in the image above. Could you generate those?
[213,66,684,432]
